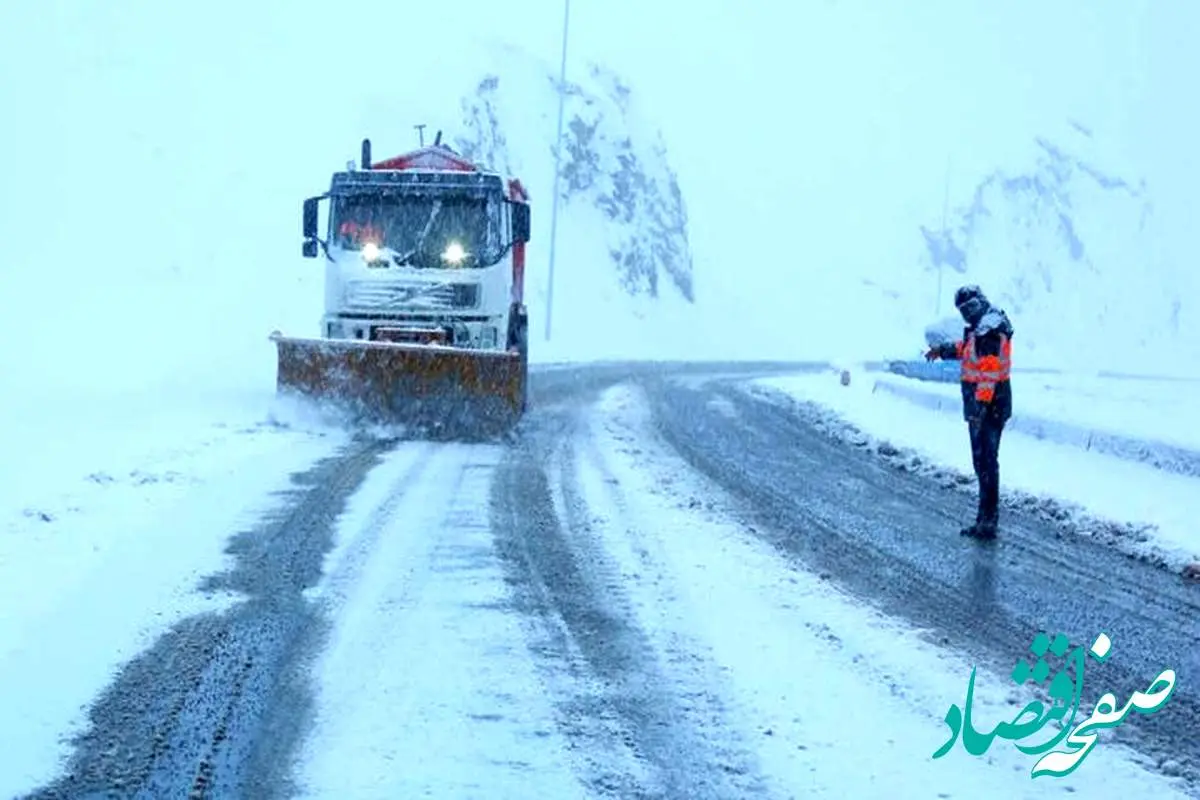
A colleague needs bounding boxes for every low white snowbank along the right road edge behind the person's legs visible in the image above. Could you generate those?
[749,373,1200,571]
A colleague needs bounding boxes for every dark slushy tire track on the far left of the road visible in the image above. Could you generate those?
[18,441,390,800]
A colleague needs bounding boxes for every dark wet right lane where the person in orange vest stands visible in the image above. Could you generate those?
[647,380,1200,790]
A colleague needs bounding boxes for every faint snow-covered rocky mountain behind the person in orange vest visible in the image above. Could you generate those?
[920,122,1180,371]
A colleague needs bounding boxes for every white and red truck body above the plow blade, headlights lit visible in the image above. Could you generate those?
[302,133,529,357]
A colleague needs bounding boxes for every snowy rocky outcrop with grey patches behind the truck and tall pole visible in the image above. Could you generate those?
[452,49,695,302]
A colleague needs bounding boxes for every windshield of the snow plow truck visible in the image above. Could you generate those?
[331,194,506,267]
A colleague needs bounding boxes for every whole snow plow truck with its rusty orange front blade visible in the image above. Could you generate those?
[271,132,529,438]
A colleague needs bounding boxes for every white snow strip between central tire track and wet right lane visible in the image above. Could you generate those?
[577,383,1187,800]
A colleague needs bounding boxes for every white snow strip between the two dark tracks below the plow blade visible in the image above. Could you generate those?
[293,444,583,800]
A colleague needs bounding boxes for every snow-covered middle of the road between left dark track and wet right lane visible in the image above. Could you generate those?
[296,385,1183,799]
